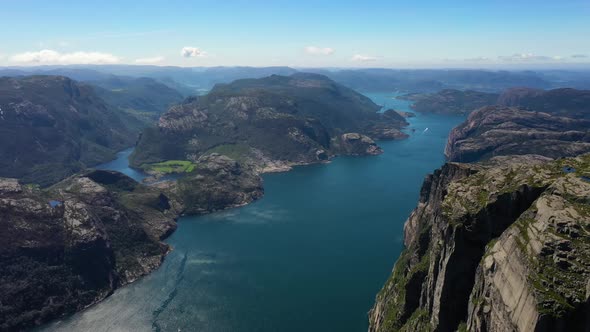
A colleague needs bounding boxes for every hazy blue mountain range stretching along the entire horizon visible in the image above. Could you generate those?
[5,65,590,92]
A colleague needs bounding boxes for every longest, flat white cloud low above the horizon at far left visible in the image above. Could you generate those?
[10,50,121,65]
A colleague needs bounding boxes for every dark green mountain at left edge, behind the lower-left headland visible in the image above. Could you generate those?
[0,76,144,185]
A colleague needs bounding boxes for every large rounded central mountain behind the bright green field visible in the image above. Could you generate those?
[131,73,407,168]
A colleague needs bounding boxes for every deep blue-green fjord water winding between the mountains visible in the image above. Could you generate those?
[42,94,462,331]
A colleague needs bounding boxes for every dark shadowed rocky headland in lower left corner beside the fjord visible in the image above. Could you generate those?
[0,171,180,331]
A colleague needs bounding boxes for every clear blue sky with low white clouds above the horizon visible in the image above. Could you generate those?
[0,0,590,67]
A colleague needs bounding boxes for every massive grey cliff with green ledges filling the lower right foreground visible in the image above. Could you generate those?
[369,155,590,331]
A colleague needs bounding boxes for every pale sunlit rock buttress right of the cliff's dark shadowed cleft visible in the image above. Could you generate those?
[467,171,590,331]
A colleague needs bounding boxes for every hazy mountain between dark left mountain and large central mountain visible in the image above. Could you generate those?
[88,76,184,120]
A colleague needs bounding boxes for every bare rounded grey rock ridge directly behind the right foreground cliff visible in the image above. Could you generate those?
[445,106,590,162]
